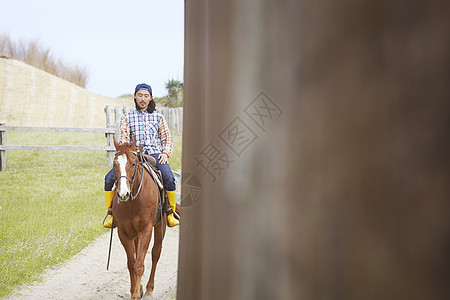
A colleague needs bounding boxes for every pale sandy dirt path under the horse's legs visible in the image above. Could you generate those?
[9,226,179,300]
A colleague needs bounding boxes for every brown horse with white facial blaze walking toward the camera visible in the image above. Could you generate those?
[112,139,167,300]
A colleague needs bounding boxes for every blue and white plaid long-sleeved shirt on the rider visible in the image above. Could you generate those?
[119,109,173,157]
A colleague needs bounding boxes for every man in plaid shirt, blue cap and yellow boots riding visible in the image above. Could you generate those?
[103,83,180,228]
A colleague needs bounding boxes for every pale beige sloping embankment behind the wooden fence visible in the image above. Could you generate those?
[0,58,128,128]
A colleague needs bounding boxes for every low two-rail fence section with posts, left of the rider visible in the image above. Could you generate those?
[0,123,116,171]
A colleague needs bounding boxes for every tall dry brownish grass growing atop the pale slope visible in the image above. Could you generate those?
[0,34,89,88]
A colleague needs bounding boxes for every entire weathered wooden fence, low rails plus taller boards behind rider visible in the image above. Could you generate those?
[0,106,183,171]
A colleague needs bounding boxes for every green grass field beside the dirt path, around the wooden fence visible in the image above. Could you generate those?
[0,132,181,298]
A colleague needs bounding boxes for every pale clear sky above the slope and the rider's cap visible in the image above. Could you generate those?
[0,0,184,97]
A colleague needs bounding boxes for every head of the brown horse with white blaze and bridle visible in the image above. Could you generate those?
[113,138,138,202]
